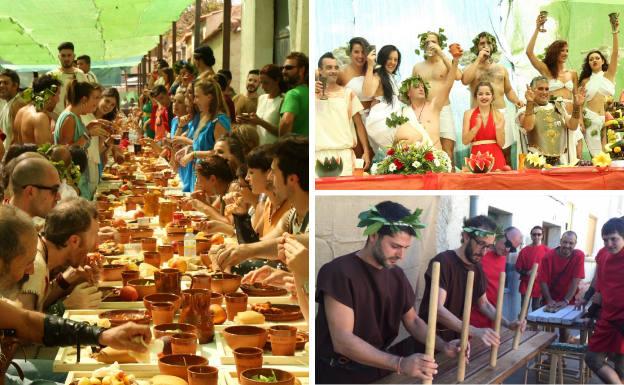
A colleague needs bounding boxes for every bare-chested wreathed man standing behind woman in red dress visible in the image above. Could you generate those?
[462,32,524,164]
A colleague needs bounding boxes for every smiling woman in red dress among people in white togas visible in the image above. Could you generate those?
[462,82,506,170]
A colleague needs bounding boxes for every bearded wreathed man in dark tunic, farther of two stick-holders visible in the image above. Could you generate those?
[419,215,526,346]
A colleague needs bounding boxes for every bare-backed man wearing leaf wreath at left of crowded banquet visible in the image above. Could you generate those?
[13,75,61,145]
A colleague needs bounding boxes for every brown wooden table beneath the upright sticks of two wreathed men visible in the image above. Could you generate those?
[376,329,556,384]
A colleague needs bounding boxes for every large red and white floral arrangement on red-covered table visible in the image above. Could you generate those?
[372,143,451,175]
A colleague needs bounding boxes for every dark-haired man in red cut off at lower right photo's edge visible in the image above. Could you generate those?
[585,218,624,384]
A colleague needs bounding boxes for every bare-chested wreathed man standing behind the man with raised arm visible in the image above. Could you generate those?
[412,31,462,164]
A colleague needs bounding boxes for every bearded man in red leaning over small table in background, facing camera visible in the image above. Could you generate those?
[537,231,585,342]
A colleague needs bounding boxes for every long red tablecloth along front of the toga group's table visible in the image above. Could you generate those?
[316,167,624,190]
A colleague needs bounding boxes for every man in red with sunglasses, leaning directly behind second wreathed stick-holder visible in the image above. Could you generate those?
[470,227,522,328]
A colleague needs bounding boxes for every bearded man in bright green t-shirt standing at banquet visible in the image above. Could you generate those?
[278,52,309,136]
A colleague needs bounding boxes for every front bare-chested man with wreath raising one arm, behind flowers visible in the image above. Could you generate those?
[396,42,461,159]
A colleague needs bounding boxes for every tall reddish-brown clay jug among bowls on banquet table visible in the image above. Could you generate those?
[179,289,214,344]
